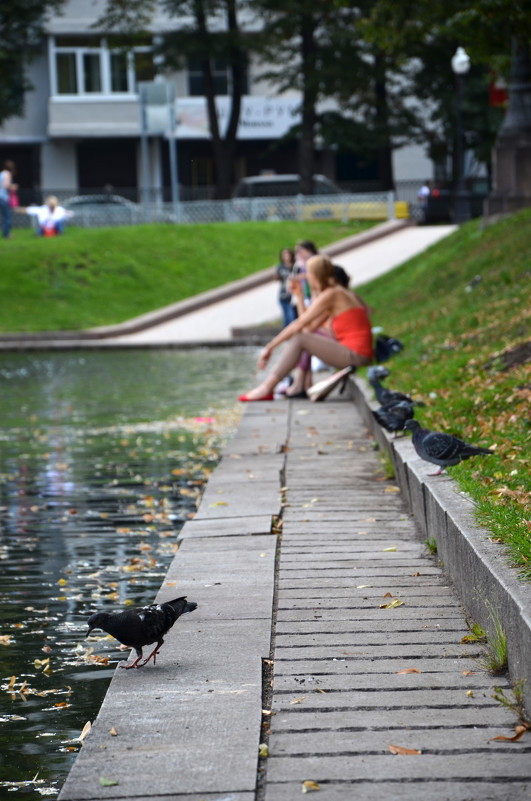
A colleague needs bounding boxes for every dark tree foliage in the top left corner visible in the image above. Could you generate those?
[0,0,64,124]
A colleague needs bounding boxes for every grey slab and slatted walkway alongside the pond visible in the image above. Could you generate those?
[60,395,531,801]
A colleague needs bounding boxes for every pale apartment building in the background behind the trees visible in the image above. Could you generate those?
[0,0,432,202]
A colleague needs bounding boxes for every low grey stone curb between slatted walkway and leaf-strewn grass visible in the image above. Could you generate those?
[351,378,531,710]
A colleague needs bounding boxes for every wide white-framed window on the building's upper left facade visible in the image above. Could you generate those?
[50,36,156,95]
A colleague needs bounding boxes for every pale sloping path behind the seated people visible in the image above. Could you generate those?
[106,225,456,345]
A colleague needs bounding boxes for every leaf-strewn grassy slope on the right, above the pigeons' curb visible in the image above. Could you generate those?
[360,210,531,578]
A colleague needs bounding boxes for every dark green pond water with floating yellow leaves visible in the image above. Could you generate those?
[0,349,256,799]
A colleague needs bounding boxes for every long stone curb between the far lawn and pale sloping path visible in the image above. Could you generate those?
[0,220,412,347]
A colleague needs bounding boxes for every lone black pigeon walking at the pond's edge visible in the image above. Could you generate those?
[87,597,197,670]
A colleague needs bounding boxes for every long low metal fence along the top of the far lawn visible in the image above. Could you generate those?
[13,190,410,228]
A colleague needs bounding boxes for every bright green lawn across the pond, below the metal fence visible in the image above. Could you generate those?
[0,221,373,332]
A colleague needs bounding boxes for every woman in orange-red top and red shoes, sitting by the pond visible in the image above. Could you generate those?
[239,256,373,402]
